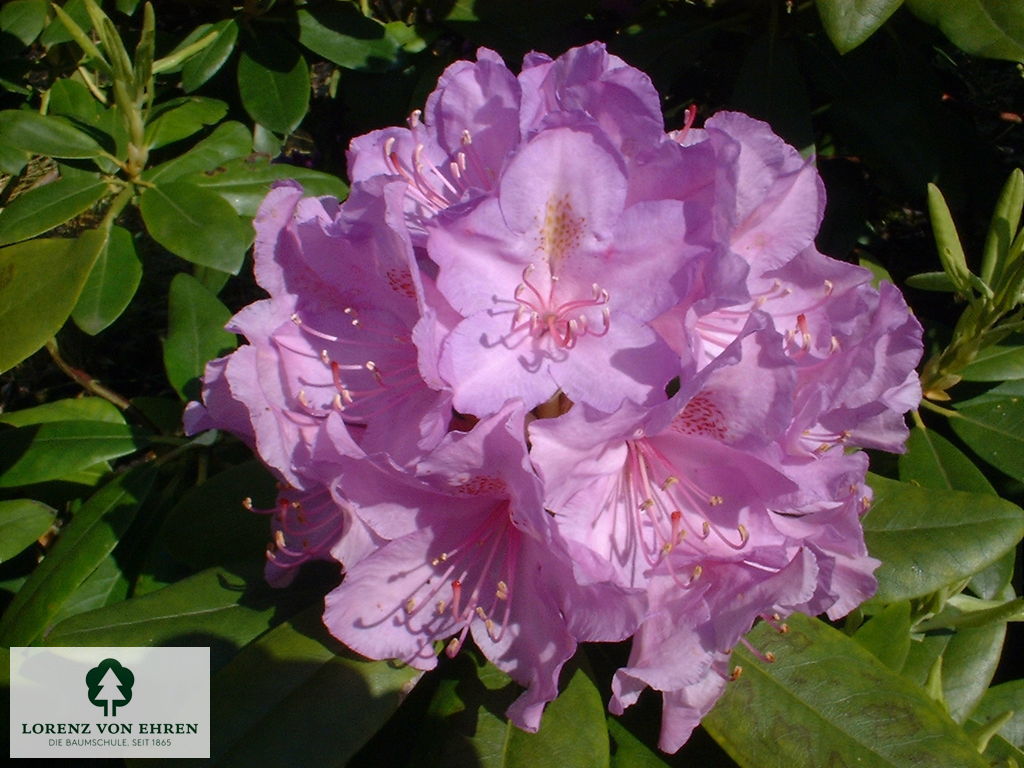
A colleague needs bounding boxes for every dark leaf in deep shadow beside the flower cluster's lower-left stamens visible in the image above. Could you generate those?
[160,460,278,568]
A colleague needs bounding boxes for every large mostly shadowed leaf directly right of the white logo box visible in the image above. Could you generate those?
[210,605,421,768]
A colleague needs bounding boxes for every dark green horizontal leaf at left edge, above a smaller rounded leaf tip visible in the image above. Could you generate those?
[0,421,140,488]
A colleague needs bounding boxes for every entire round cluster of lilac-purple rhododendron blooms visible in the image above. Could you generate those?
[186,43,922,751]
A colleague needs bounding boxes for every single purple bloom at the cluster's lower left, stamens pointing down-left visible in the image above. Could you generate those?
[324,401,642,730]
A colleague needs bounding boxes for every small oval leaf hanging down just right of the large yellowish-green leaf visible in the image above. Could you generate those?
[71,226,142,336]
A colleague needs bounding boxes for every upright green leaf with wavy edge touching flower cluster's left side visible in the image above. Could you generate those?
[164,272,238,400]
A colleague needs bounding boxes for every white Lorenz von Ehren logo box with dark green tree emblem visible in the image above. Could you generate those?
[10,646,210,758]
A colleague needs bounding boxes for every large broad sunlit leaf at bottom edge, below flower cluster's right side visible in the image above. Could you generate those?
[703,614,988,768]
